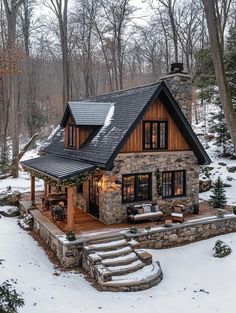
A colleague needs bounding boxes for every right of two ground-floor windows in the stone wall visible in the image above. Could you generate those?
[162,171,186,198]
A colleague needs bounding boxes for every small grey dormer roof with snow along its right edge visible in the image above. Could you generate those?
[61,101,114,127]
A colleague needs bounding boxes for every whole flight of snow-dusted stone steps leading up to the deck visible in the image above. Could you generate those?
[83,236,162,291]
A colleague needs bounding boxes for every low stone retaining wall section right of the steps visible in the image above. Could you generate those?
[128,216,236,249]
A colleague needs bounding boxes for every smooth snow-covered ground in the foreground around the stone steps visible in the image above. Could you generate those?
[0,214,236,313]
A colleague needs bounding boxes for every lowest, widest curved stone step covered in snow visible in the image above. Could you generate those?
[102,262,163,291]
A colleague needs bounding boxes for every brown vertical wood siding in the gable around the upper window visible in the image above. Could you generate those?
[120,100,190,153]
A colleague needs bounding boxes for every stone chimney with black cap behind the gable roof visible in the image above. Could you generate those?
[161,63,193,124]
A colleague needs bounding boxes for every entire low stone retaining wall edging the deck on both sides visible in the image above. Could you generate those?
[31,210,236,269]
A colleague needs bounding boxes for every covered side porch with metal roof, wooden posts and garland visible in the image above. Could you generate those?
[21,155,100,232]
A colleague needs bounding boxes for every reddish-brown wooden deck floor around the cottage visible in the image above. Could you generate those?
[18,192,223,235]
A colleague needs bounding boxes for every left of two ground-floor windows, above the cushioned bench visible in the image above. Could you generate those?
[122,173,152,202]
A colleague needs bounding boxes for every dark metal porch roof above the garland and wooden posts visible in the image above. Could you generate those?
[21,154,96,181]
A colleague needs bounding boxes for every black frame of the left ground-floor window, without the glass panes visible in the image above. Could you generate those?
[121,172,152,203]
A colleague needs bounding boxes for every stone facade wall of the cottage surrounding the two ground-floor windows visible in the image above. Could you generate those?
[99,151,199,224]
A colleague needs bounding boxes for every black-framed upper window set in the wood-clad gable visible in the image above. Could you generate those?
[143,121,168,150]
